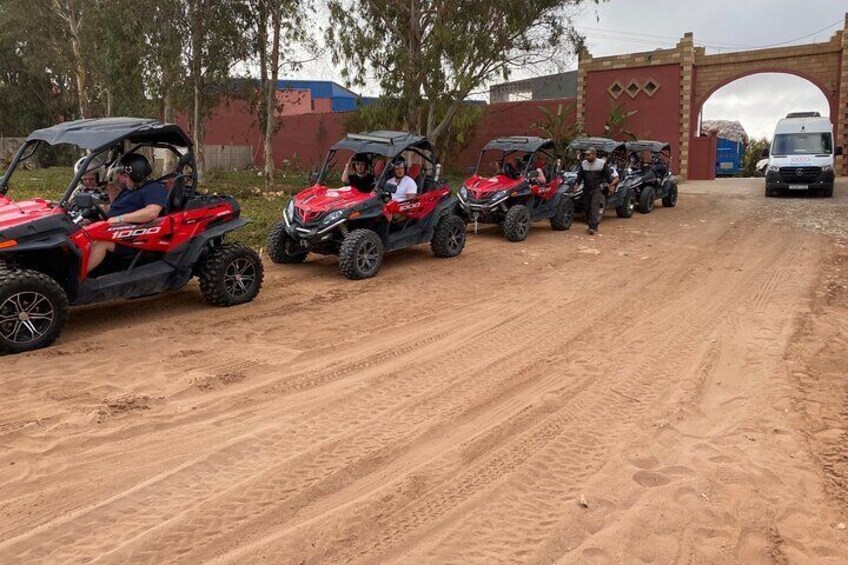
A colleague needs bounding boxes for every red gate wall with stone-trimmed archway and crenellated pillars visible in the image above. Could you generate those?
[577,14,848,179]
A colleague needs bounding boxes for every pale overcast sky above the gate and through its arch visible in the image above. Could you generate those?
[295,0,848,137]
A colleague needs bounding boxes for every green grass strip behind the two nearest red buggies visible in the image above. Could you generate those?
[1,167,470,249]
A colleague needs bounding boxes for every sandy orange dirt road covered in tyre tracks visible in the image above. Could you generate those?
[0,175,848,564]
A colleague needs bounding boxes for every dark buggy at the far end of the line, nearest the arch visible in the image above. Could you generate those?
[622,140,677,214]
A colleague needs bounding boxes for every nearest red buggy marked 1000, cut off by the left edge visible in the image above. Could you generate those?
[0,118,263,353]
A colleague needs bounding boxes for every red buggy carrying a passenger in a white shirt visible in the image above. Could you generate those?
[268,131,465,280]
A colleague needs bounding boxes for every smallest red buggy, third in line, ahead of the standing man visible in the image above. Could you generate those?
[459,137,574,241]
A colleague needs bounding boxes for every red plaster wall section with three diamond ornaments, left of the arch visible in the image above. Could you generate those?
[584,64,680,156]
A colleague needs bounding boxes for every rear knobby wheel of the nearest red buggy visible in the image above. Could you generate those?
[198,243,264,306]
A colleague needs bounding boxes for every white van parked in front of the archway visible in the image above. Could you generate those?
[764,112,842,196]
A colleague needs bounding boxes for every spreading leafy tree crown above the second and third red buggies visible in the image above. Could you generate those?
[327,0,599,147]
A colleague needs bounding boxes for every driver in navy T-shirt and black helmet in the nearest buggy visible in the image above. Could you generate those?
[88,153,168,272]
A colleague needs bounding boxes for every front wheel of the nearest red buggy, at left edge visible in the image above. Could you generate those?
[0,266,68,353]
